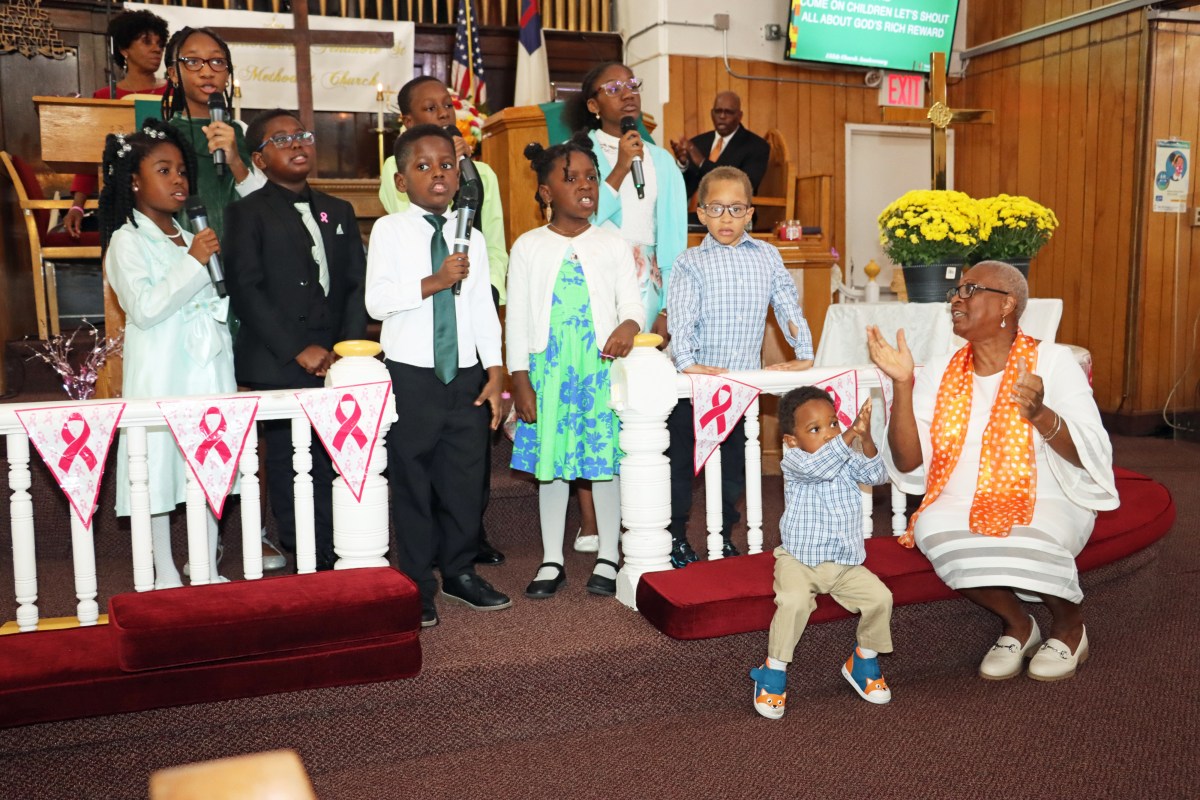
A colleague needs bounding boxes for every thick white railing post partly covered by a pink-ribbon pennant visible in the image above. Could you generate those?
[325,341,397,570]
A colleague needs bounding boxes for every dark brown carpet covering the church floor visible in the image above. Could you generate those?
[0,429,1200,800]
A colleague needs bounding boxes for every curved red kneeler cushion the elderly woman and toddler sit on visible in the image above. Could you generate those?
[637,468,1175,639]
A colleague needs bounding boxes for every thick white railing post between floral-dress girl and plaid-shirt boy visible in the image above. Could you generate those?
[612,333,678,608]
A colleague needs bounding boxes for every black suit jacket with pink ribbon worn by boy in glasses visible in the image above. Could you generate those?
[221,182,367,387]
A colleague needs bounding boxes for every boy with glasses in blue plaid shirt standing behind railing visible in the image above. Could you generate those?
[667,167,812,570]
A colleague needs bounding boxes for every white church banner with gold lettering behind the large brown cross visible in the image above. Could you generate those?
[124,2,415,112]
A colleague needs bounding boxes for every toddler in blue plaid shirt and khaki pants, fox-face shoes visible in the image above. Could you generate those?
[750,386,892,720]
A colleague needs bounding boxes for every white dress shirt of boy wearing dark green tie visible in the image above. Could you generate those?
[366,204,503,369]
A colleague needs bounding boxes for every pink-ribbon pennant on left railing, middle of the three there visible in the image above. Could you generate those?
[158,396,258,519]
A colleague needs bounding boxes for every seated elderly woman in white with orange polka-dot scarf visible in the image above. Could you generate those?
[868,261,1118,680]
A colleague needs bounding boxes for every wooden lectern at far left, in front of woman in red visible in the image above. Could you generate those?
[34,95,147,397]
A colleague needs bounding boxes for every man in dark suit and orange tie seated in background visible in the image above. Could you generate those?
[671,91,770,198]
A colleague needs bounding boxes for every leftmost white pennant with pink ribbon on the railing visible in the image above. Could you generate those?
[17,403,125,528]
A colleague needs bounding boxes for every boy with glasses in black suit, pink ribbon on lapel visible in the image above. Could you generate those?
[221,109,367,570]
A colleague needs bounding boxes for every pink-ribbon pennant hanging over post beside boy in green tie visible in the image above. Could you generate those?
[296,380,391,503]
